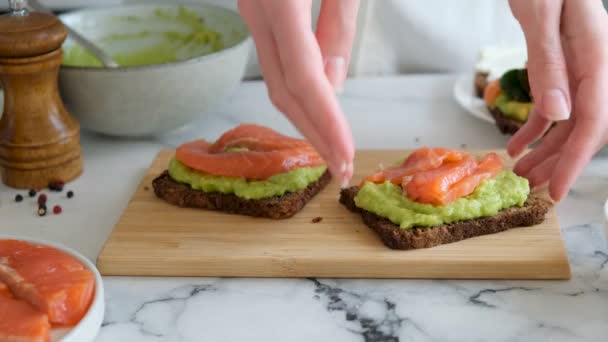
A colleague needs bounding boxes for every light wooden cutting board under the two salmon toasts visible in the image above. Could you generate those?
[97,150,570,279]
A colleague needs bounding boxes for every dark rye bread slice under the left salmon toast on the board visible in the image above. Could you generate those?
[152,171,331,219]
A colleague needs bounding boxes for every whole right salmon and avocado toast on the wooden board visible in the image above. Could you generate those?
[340,148,550,249]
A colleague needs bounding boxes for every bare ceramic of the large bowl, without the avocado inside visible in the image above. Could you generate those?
[59,4,251,136]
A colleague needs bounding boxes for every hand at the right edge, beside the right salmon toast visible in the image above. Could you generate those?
[508,0,608,201]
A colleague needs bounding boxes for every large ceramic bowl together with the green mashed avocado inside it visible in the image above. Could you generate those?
[59,3,251,137]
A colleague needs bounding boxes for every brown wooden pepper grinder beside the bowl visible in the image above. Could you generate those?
[0,0,82,189]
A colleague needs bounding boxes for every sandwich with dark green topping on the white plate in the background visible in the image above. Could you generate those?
[484,69,533,134]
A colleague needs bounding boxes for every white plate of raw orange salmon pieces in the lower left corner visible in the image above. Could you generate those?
[0,236,104,342]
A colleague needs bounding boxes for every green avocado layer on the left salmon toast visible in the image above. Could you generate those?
[169,159,327,199]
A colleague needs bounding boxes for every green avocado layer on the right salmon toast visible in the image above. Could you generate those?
[355,171,530,229]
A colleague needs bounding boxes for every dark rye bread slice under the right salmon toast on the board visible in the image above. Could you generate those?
[340,186,551,249]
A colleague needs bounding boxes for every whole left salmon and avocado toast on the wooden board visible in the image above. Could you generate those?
[152,124,330,219]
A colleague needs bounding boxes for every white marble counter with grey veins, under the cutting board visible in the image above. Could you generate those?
[0,76,608,342]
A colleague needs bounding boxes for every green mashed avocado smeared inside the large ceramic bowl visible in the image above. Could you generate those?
[63,6,224,67]
